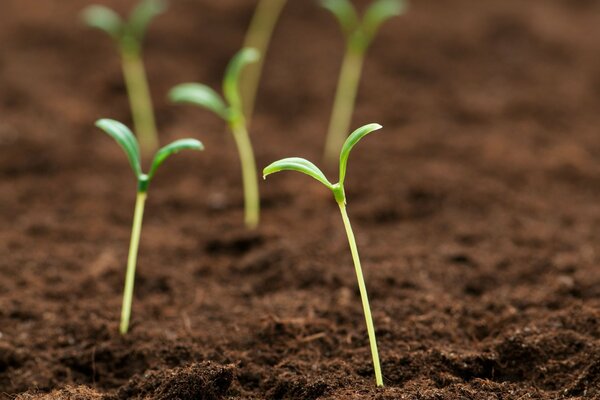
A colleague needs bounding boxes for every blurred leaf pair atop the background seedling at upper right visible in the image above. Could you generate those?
[321,0,407,41]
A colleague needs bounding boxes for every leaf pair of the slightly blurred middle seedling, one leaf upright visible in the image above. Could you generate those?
[169,47,260,121]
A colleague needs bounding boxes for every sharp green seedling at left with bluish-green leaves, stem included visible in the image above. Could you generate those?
[96,119,204,335]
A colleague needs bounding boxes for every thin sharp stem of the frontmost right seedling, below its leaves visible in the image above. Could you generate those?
[338,201,383,386]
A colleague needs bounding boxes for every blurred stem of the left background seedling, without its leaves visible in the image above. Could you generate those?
[122,50,158,155]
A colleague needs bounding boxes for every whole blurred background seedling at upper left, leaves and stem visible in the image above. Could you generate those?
[82,0,166,155]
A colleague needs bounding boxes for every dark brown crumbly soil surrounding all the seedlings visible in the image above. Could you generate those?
[0,0,600,400]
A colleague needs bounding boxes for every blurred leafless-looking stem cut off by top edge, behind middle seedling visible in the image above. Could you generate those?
[240,0,287,125]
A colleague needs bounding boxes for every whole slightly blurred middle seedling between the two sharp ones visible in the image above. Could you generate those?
[169,48,260,228]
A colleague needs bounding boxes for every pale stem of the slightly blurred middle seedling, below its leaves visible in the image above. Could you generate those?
[230,122,260,229]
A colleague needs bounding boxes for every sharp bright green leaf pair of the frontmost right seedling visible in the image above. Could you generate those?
[263,124,382,196]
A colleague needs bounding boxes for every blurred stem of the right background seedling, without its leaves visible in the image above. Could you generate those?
[324,45,364,164]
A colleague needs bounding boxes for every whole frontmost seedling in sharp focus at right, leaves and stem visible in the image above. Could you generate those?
[263,124,383,386]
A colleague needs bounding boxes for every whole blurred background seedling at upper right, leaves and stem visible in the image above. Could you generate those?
[321,0,406,164]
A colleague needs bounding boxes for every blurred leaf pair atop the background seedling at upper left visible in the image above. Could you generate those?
[82,0,167,43]
